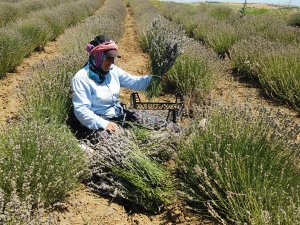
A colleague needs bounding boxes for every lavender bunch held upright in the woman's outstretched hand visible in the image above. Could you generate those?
[143,18,183,98]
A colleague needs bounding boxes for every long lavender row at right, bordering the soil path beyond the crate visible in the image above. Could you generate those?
[160,3,300,110]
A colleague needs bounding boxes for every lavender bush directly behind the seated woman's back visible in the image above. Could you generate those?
[24,55,84,123]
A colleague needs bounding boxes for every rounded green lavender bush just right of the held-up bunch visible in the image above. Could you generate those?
[168,44,221,109]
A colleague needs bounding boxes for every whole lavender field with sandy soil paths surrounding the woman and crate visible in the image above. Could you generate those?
[0,0,300,225]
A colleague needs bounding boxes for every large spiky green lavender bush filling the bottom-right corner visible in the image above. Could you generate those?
[180,108,300,225]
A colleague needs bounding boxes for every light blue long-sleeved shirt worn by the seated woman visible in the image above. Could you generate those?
[71,65,152,129]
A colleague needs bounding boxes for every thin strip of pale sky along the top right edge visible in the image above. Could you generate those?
[163,0,300,6]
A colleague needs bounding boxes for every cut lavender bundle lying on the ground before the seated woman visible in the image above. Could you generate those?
[87,129,173,212]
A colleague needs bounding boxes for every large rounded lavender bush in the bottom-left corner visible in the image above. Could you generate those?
[0,120,85,221]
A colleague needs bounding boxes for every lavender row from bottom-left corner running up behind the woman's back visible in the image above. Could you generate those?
[0,0,125,221]
